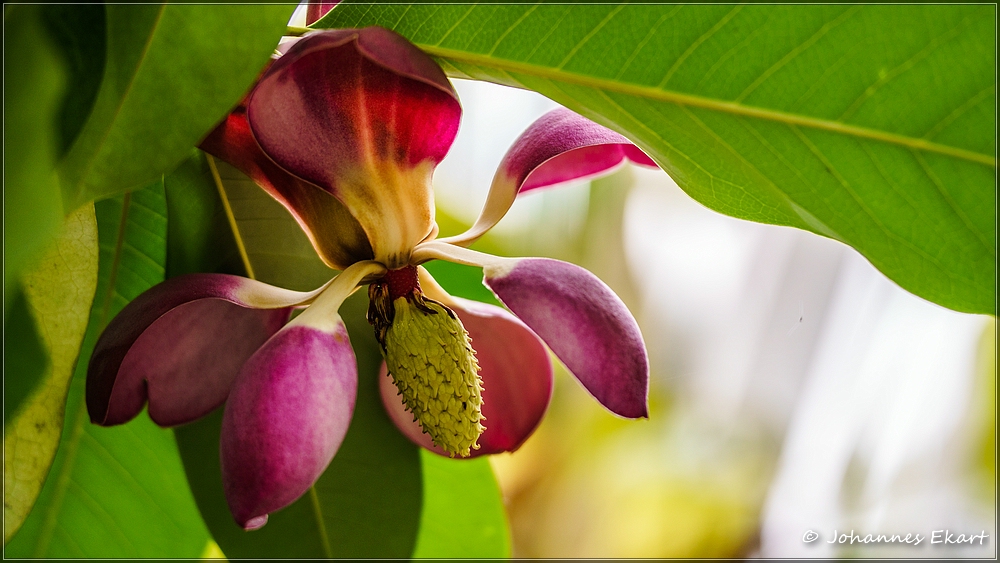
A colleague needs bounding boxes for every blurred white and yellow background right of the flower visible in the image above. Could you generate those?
[435,81,996,557]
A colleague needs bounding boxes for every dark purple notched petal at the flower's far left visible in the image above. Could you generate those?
[87,274,312,426]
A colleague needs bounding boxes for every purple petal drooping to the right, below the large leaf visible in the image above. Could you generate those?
[483,258,649,418]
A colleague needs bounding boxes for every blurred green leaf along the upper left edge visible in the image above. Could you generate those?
[3,6,66,310]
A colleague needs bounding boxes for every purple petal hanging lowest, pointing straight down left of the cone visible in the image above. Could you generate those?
[220,318,357,530]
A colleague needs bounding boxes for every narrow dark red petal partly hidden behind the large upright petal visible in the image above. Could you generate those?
[200,105,372,270]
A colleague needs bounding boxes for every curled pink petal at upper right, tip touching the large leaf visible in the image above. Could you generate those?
[441,108,656,246]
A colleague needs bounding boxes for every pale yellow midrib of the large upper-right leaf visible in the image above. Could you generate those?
[416,43,996,168]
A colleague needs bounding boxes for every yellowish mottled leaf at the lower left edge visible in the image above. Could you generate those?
[3,205,98,543]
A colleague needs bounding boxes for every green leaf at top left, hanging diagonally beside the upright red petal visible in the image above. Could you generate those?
[59,4,295,206]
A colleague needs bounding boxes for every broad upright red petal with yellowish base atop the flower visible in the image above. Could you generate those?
[247,27,461,268]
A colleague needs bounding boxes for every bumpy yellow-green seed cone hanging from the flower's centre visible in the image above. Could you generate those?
[385,297,486,457]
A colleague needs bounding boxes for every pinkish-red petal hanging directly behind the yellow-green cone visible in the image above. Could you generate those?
[379,297,553,457]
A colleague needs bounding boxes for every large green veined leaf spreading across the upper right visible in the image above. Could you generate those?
[324,3,996,313]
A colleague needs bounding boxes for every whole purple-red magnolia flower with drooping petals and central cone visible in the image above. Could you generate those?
[87,28,655,530]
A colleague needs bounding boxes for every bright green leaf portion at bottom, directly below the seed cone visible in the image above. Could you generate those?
[413,450,510,559]
